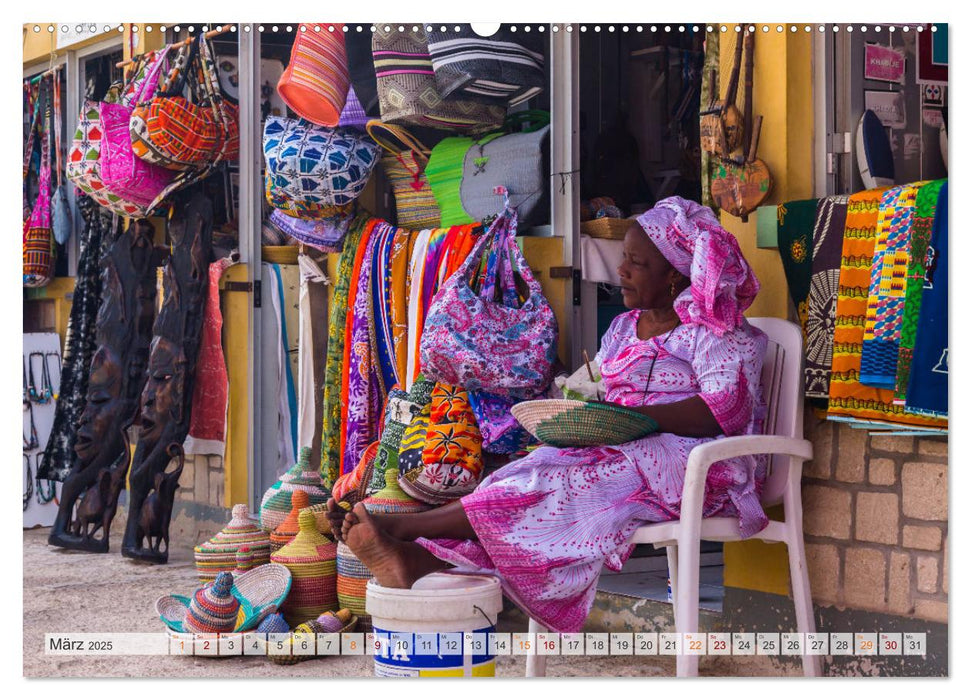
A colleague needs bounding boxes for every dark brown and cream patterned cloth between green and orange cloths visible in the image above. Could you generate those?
[805,195,849,399]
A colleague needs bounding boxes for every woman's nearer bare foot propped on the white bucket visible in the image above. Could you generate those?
[342,503,446,588]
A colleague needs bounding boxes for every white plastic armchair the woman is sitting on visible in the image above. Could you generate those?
[526,318,820,676]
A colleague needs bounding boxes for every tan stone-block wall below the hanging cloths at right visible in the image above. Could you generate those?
[803,416,948,623]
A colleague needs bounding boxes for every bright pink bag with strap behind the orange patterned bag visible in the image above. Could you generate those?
[100,47,176,213]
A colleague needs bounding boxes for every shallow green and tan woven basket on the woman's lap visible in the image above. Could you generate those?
[511,399,657,447]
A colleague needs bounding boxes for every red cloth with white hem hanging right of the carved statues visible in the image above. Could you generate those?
[182,257,235,457]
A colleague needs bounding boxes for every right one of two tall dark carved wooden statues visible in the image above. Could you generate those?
[121,188,213,564]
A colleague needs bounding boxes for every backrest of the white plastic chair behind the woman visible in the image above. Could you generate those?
[748,317,804,505]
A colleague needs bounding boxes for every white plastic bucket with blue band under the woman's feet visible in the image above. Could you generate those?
[365,573,502,677]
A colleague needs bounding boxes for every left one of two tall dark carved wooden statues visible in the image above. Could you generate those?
[47,220,158,553]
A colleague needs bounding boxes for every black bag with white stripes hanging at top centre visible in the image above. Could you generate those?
[428,24,546,107]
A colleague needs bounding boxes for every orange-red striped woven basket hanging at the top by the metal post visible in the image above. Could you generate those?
[276,22,350,126]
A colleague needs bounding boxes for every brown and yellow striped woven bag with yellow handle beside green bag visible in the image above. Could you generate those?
[367,119,441,231]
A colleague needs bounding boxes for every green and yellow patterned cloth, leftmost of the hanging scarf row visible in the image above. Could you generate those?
[320,214,377,487]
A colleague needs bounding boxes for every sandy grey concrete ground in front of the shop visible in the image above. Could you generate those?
[23,528,696,678]
